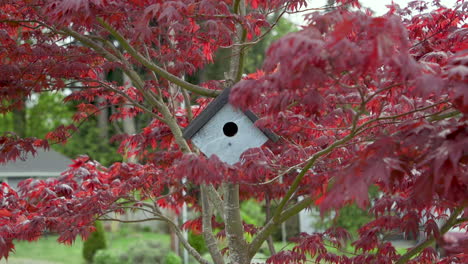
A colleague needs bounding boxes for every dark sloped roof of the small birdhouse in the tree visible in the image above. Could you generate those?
[184,88,279,142]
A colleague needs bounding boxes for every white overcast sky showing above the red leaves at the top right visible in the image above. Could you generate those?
[287,0,457,25]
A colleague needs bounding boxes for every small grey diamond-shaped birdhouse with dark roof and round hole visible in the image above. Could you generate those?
[184,88,278,165]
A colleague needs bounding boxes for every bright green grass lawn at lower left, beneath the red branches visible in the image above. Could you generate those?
[0,230,170,264]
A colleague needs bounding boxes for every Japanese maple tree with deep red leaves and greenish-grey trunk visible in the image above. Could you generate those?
[0,0,468,264]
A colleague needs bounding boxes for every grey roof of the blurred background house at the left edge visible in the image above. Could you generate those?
[0,150,71,177]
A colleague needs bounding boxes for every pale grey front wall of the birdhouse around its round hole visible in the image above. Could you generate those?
[192,104,268,165]
